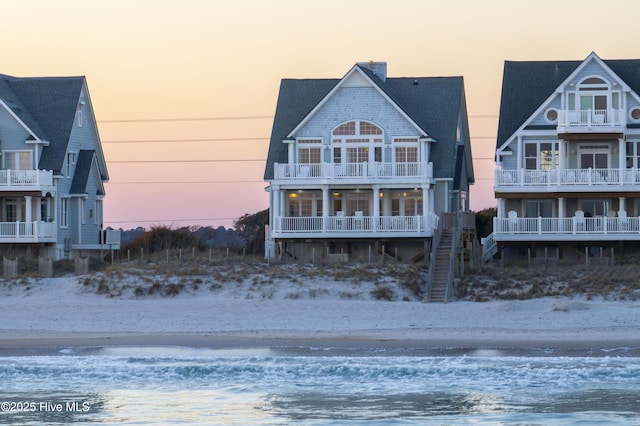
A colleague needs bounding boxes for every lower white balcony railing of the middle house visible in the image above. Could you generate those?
[271,216,437,237]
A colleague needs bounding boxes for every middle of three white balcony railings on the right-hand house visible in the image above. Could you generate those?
[495,169,640,188]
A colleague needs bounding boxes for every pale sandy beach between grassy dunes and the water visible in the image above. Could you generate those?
[0,276,640,353]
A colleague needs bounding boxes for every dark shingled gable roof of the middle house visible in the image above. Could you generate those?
[264,64,473,181]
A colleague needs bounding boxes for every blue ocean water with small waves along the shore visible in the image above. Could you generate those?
[0,347,640,425]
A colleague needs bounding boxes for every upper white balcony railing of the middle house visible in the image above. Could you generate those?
[274,162,433,180]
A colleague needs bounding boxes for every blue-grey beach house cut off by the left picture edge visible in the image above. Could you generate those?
[0,75,120,259]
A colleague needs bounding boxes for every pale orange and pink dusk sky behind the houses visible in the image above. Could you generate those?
[0,0,640,229]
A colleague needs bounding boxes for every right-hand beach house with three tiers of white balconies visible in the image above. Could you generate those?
[485,53,640,258]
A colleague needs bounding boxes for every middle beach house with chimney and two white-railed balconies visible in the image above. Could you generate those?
[264,62,474,261]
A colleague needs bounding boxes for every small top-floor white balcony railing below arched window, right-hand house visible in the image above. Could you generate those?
[558,109,627,134]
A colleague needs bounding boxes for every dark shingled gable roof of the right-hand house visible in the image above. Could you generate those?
[497,55,640,148]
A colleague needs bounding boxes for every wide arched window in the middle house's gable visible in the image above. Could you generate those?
[331,120,384,163]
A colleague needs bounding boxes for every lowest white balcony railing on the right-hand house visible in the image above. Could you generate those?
[493,216,640,241]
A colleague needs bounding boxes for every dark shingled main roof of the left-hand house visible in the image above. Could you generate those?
[0,75,85,173]
